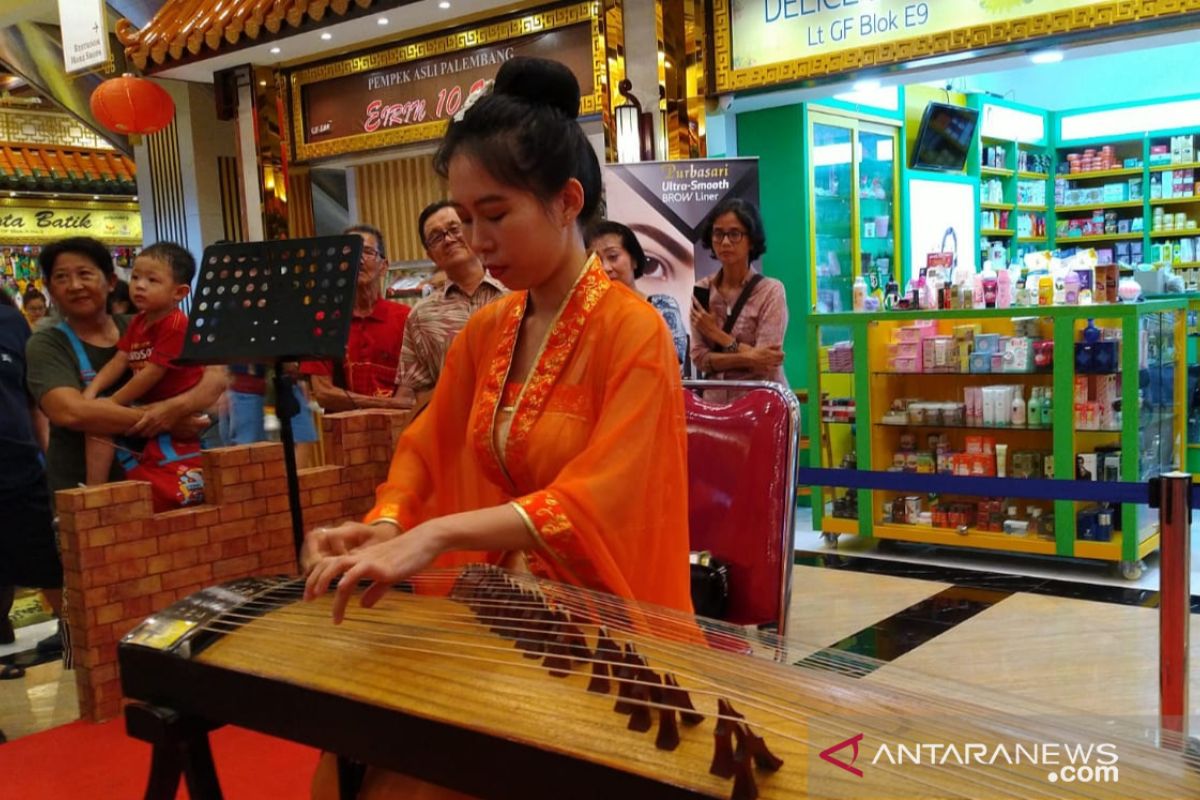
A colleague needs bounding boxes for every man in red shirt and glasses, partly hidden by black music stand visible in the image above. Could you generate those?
[301,224,412,411]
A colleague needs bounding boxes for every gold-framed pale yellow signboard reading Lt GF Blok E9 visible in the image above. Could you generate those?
[713,0,1200,91]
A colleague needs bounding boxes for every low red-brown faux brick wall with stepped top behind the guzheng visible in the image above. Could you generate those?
[58,411,401,721]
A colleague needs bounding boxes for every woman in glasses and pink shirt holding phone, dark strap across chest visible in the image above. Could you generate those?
[691,198,788,401]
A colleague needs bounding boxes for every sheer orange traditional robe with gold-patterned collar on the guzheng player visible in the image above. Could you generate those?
[313,258,691,800]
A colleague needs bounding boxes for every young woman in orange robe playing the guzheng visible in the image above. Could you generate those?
[302,59,691,798]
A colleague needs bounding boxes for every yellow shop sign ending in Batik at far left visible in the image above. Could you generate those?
[0,200,142,245]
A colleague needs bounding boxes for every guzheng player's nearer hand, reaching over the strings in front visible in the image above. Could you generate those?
[305,522,445,624]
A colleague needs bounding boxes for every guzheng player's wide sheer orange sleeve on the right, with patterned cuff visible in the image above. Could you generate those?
[515,300,691,612]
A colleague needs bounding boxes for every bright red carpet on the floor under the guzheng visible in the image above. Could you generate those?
[0,718,318,800]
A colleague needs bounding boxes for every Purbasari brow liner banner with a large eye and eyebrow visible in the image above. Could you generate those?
[604,158,758,326]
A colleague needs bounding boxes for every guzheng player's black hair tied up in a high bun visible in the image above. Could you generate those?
[433,56,601,228]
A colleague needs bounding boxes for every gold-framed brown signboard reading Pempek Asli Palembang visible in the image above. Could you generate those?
[289,2,605,161]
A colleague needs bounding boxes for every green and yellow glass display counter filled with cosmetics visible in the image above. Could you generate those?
[808,297,1188,578]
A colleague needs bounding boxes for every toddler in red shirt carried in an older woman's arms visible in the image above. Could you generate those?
[83,242,204,486]
